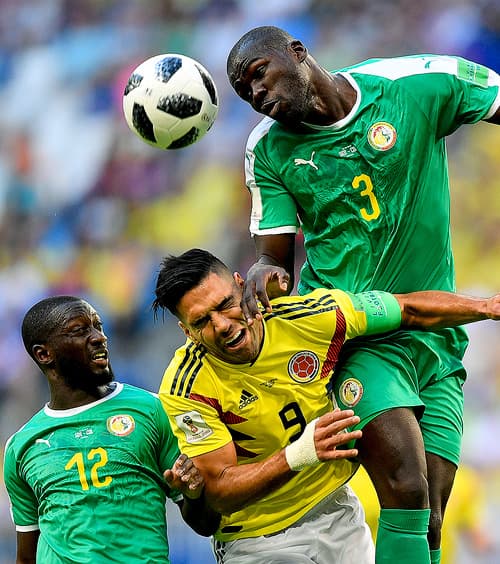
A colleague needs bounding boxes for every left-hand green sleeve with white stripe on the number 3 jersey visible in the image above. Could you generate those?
[245,120,299,235]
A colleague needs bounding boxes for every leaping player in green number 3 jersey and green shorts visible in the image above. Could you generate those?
[227,26,500,564]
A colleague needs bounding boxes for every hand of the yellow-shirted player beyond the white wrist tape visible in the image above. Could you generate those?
[314,408,362,460]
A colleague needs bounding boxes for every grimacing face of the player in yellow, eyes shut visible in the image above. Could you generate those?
[177,272,263,364]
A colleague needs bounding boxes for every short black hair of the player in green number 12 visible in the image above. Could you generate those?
[21,296,83,359]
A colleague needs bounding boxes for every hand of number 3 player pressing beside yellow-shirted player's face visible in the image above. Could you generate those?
[241,262,290,325]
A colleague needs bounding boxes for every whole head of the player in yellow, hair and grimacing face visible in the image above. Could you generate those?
[153,249,263,364]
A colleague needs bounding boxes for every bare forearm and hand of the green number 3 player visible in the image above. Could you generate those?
[241,233,295,322]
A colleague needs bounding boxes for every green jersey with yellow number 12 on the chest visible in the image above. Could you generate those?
[4,383,181,564]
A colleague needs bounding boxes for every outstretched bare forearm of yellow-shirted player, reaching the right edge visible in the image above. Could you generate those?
[394,291,500,329]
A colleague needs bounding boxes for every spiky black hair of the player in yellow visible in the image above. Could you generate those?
[152,249,231,318]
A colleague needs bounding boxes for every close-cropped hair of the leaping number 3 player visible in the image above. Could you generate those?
[226,25,294,84]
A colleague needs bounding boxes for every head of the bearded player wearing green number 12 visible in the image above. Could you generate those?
[21,296,113,393]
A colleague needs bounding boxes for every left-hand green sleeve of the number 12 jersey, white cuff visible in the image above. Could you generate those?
[4,439,39,532]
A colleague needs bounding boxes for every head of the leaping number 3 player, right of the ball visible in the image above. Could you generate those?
[227,26,314,127]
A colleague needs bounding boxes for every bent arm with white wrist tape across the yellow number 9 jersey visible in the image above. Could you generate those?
[190,409,361,514]
